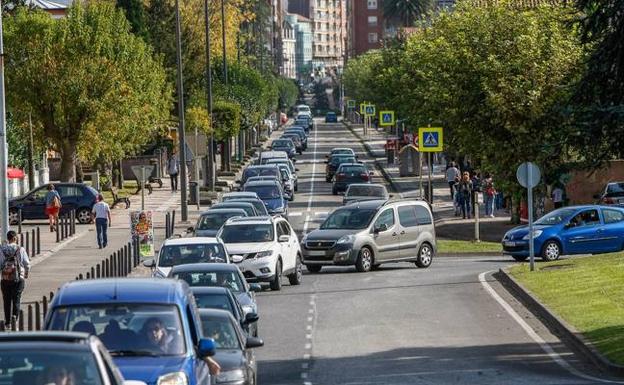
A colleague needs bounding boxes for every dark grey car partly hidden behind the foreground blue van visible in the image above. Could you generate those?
[199,309,264,385]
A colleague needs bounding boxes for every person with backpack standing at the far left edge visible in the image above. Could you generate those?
[0,230,30,325]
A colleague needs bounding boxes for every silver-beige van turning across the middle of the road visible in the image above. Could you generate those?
[302,200,436,272]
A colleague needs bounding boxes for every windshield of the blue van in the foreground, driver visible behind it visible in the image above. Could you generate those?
[50,303,186,356]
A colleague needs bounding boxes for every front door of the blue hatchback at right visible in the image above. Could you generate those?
[562,209,604,254]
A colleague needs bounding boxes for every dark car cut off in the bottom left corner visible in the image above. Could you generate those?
[0,330,146,385]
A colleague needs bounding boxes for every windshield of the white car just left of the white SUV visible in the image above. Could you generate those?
[158,242,227,267]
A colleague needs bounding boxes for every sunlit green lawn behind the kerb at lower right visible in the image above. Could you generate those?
[510,253,624,365]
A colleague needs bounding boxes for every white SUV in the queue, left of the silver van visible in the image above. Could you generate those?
[217,216,303,290]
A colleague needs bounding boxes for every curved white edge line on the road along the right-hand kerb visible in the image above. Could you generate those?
[479,270,624,384]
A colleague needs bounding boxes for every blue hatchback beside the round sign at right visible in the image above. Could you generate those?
[502,205,624,261]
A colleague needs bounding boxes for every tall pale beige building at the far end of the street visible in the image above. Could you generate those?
[288,0,347,73]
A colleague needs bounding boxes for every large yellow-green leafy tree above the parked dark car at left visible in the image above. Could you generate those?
[5,2,171,181]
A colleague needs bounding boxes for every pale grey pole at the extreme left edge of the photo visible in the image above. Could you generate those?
[0,12,9,242]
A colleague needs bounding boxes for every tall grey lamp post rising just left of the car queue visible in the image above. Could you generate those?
[175,0,188,222]
